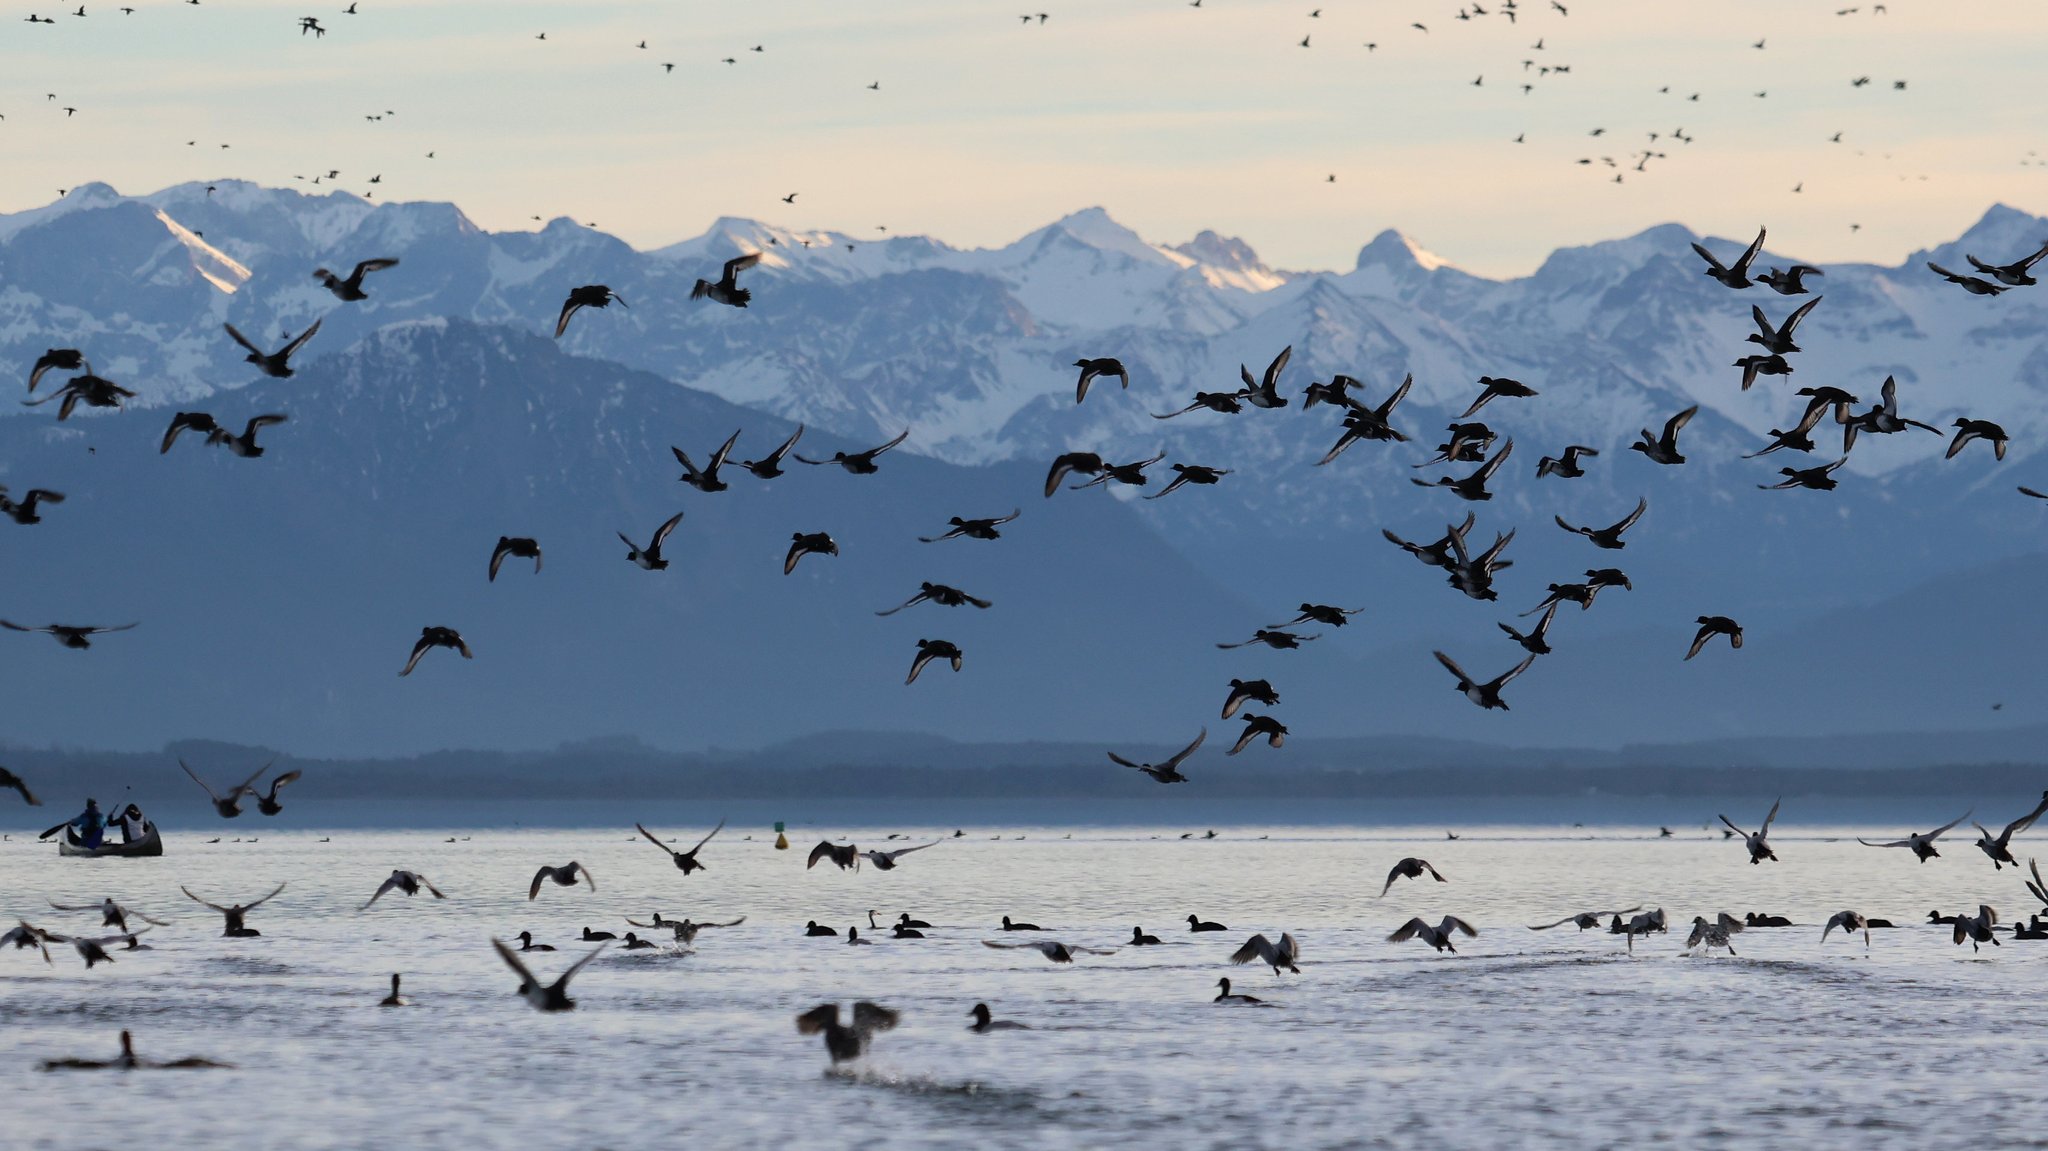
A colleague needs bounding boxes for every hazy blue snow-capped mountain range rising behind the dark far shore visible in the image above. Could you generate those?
[0,182,2048,756]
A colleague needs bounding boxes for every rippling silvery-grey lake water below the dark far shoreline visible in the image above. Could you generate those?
[0,813,2048,1151]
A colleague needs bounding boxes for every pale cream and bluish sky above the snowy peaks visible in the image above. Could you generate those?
[0,0,2048,274]
